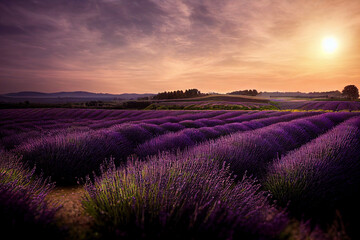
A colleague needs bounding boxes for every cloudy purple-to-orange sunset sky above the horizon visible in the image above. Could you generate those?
[0,0,360,93]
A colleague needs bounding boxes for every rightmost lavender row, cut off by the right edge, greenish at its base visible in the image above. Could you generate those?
[264,117,360,229]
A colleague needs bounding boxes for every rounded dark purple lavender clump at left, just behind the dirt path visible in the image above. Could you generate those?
[14,131,130,185]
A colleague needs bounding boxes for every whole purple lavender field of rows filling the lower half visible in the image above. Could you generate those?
[0,109,360,240]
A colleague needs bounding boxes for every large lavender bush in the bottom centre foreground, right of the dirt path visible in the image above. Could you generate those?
[83,153,287,239]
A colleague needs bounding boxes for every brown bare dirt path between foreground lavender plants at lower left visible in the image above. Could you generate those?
[47,186,92,239]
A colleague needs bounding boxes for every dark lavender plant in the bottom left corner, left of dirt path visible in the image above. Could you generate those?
[0,153,64,239]
